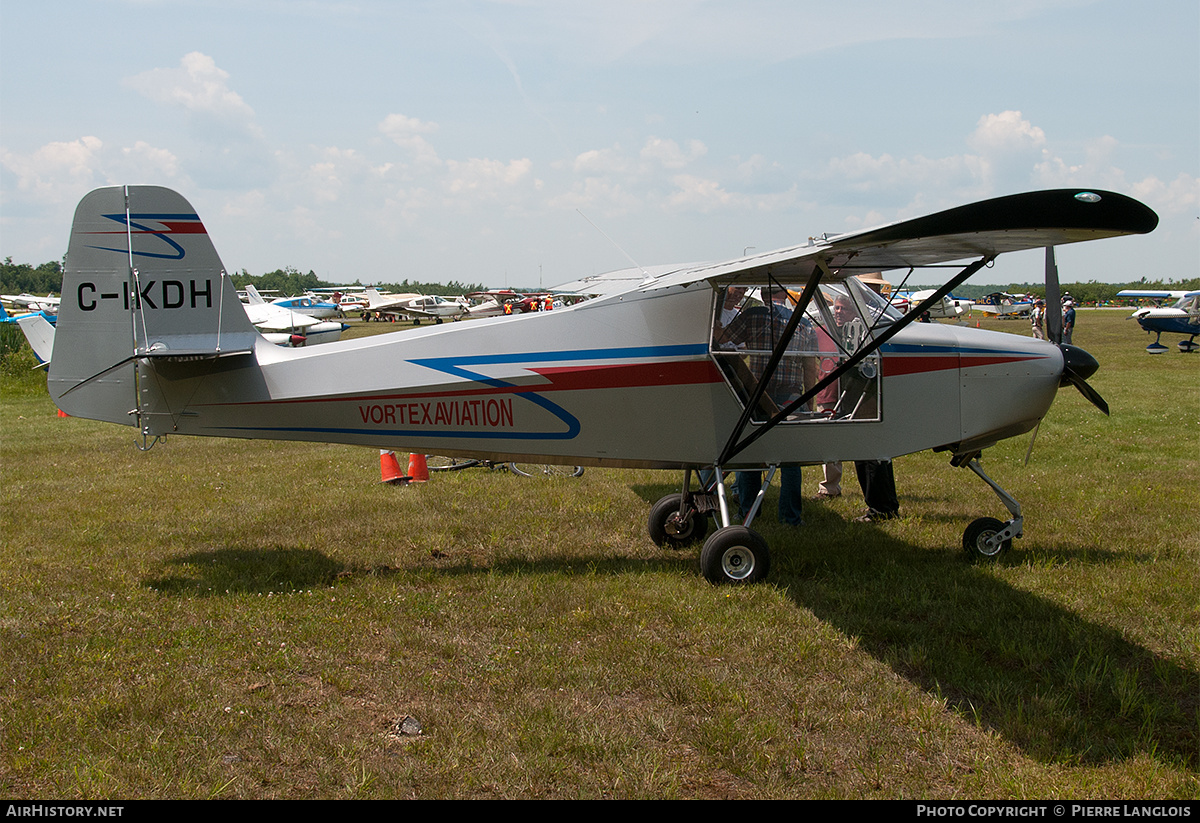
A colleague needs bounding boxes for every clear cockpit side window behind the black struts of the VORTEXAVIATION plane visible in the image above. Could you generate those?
[709,277,899,422]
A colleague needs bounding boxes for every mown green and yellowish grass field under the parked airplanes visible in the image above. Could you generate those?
[0,311,1200,799]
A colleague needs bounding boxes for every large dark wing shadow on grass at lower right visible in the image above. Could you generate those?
[634,485,1200,769]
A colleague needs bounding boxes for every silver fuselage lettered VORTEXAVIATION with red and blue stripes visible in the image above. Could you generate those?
[130,286,1062,468]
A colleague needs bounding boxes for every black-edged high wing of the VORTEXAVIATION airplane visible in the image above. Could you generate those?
[642,188,1158,292]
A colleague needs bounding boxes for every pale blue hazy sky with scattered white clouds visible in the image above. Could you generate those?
[0,0,1200,288]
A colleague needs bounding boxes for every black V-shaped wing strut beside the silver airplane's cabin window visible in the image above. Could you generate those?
[716,254,996,465]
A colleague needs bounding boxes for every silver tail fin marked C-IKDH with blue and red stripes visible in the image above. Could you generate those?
[48,186,258,426]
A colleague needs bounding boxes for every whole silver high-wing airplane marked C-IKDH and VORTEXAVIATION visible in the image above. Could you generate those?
[48,186,1158,583]
